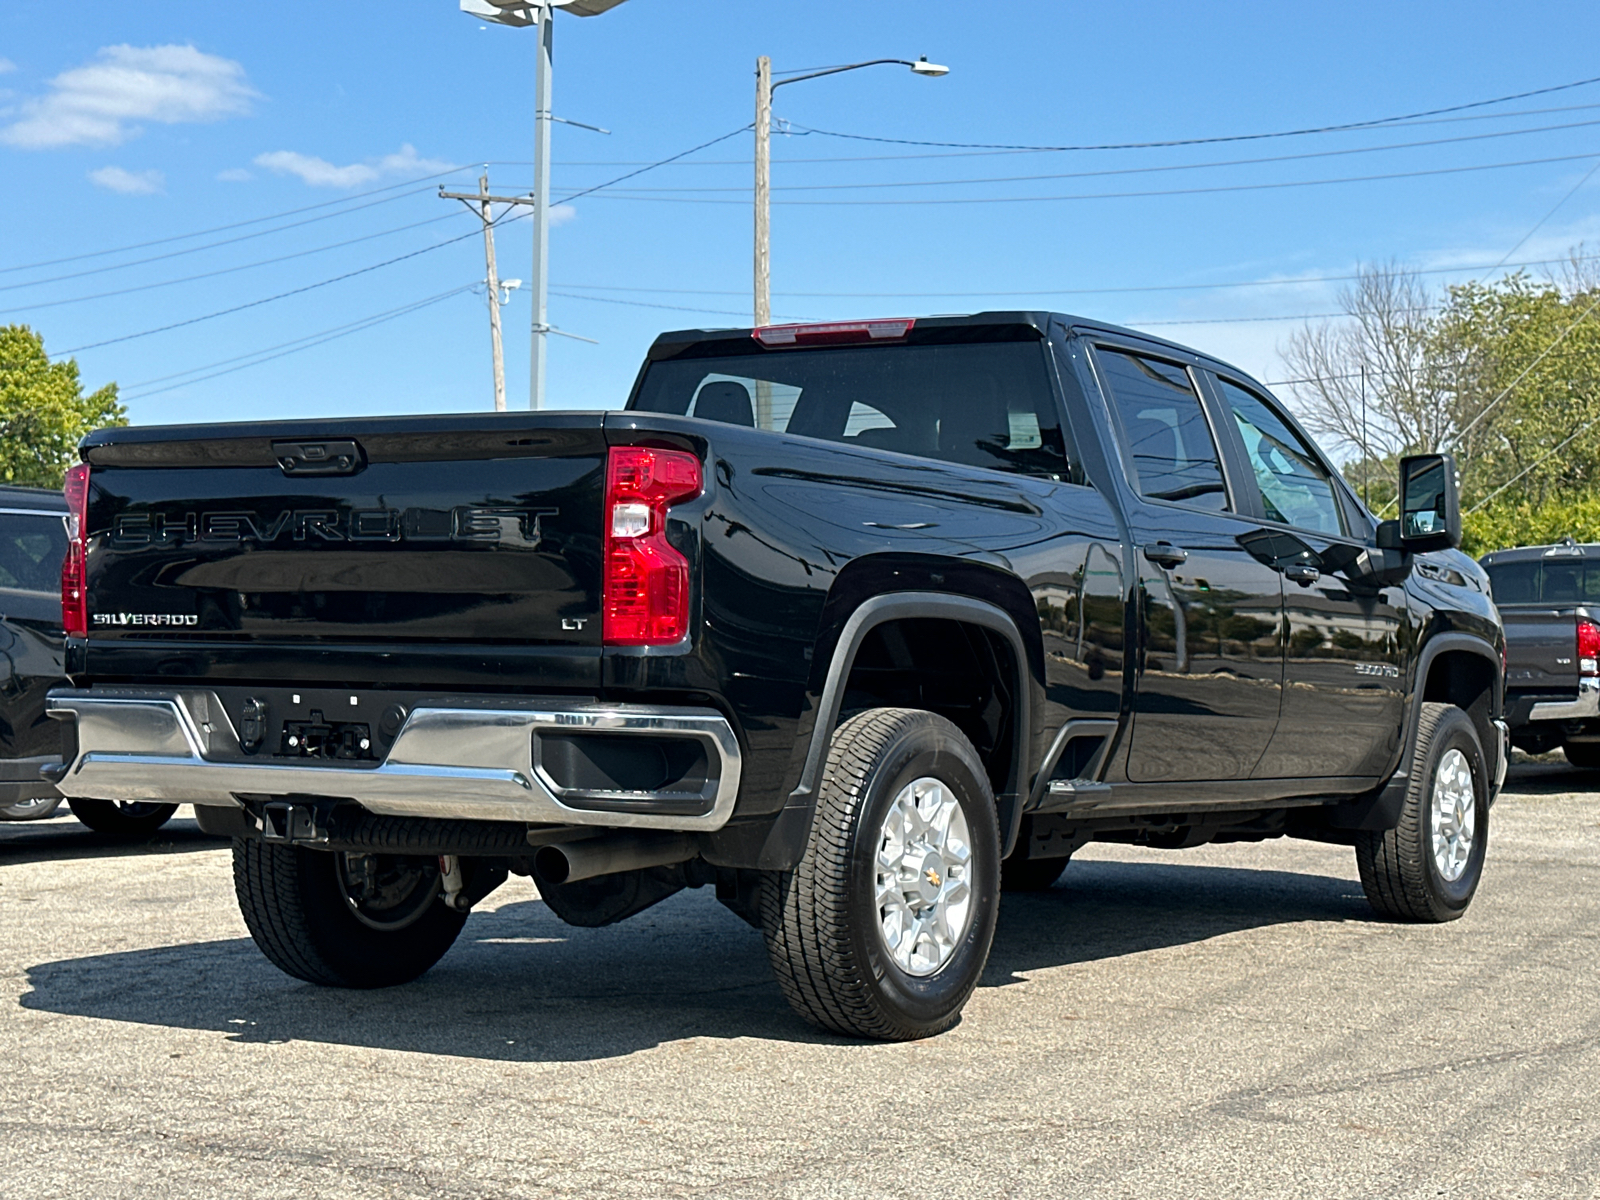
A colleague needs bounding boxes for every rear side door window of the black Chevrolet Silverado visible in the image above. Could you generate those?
[1098,346,1227,512]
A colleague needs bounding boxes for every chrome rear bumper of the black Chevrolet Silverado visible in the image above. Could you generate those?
[48,688,741,832]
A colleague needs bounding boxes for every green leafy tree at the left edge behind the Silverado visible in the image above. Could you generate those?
[0,325,128,488]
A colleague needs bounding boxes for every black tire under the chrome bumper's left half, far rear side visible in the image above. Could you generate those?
[234,838,467,987]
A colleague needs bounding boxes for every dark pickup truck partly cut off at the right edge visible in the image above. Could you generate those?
[1478,538,1600,770]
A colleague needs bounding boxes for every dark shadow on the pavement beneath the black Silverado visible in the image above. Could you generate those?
[21,861,1370,1062]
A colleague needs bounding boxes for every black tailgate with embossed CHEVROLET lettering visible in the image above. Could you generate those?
[86,413,606,659]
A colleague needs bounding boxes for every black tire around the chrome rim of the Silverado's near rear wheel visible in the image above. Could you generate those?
[758,709,1000,1042]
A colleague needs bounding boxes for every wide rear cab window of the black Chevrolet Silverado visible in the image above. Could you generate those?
[629,326,1086,483]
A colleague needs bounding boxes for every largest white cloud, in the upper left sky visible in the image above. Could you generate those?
[0,45,258,150]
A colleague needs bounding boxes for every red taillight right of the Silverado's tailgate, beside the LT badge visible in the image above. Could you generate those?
[602,446,702,646]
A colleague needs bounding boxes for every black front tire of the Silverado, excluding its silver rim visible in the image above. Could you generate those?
[1355,702,1490,922]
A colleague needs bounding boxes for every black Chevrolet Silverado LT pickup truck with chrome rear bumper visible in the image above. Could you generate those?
[51,312,1506,1038]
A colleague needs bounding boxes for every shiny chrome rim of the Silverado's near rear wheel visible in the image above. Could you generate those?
[874,776,973,976]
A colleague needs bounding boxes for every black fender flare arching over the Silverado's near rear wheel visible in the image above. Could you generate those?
[757,592,1034,870]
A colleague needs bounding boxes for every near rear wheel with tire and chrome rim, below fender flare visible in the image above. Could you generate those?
[760,709,1000,1040]
